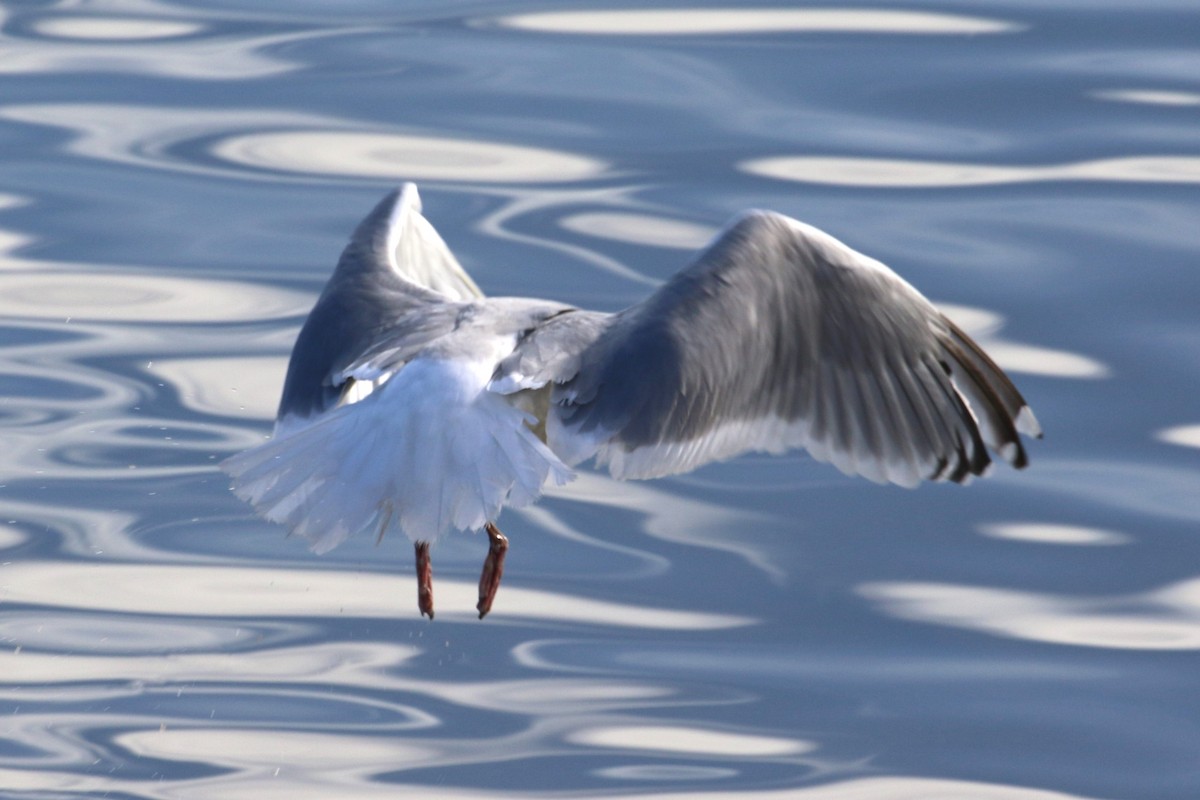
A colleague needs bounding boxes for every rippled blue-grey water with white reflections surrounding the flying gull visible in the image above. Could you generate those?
[0,0,1200,800]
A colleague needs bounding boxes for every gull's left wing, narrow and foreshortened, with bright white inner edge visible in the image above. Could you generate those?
[277,184,482,426]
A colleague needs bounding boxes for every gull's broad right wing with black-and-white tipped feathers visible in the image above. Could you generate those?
[547,212,1040,486]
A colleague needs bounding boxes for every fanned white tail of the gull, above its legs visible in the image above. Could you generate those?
[222,359,572,552]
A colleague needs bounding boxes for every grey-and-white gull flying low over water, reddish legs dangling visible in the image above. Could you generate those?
[221,184,1042,619]
